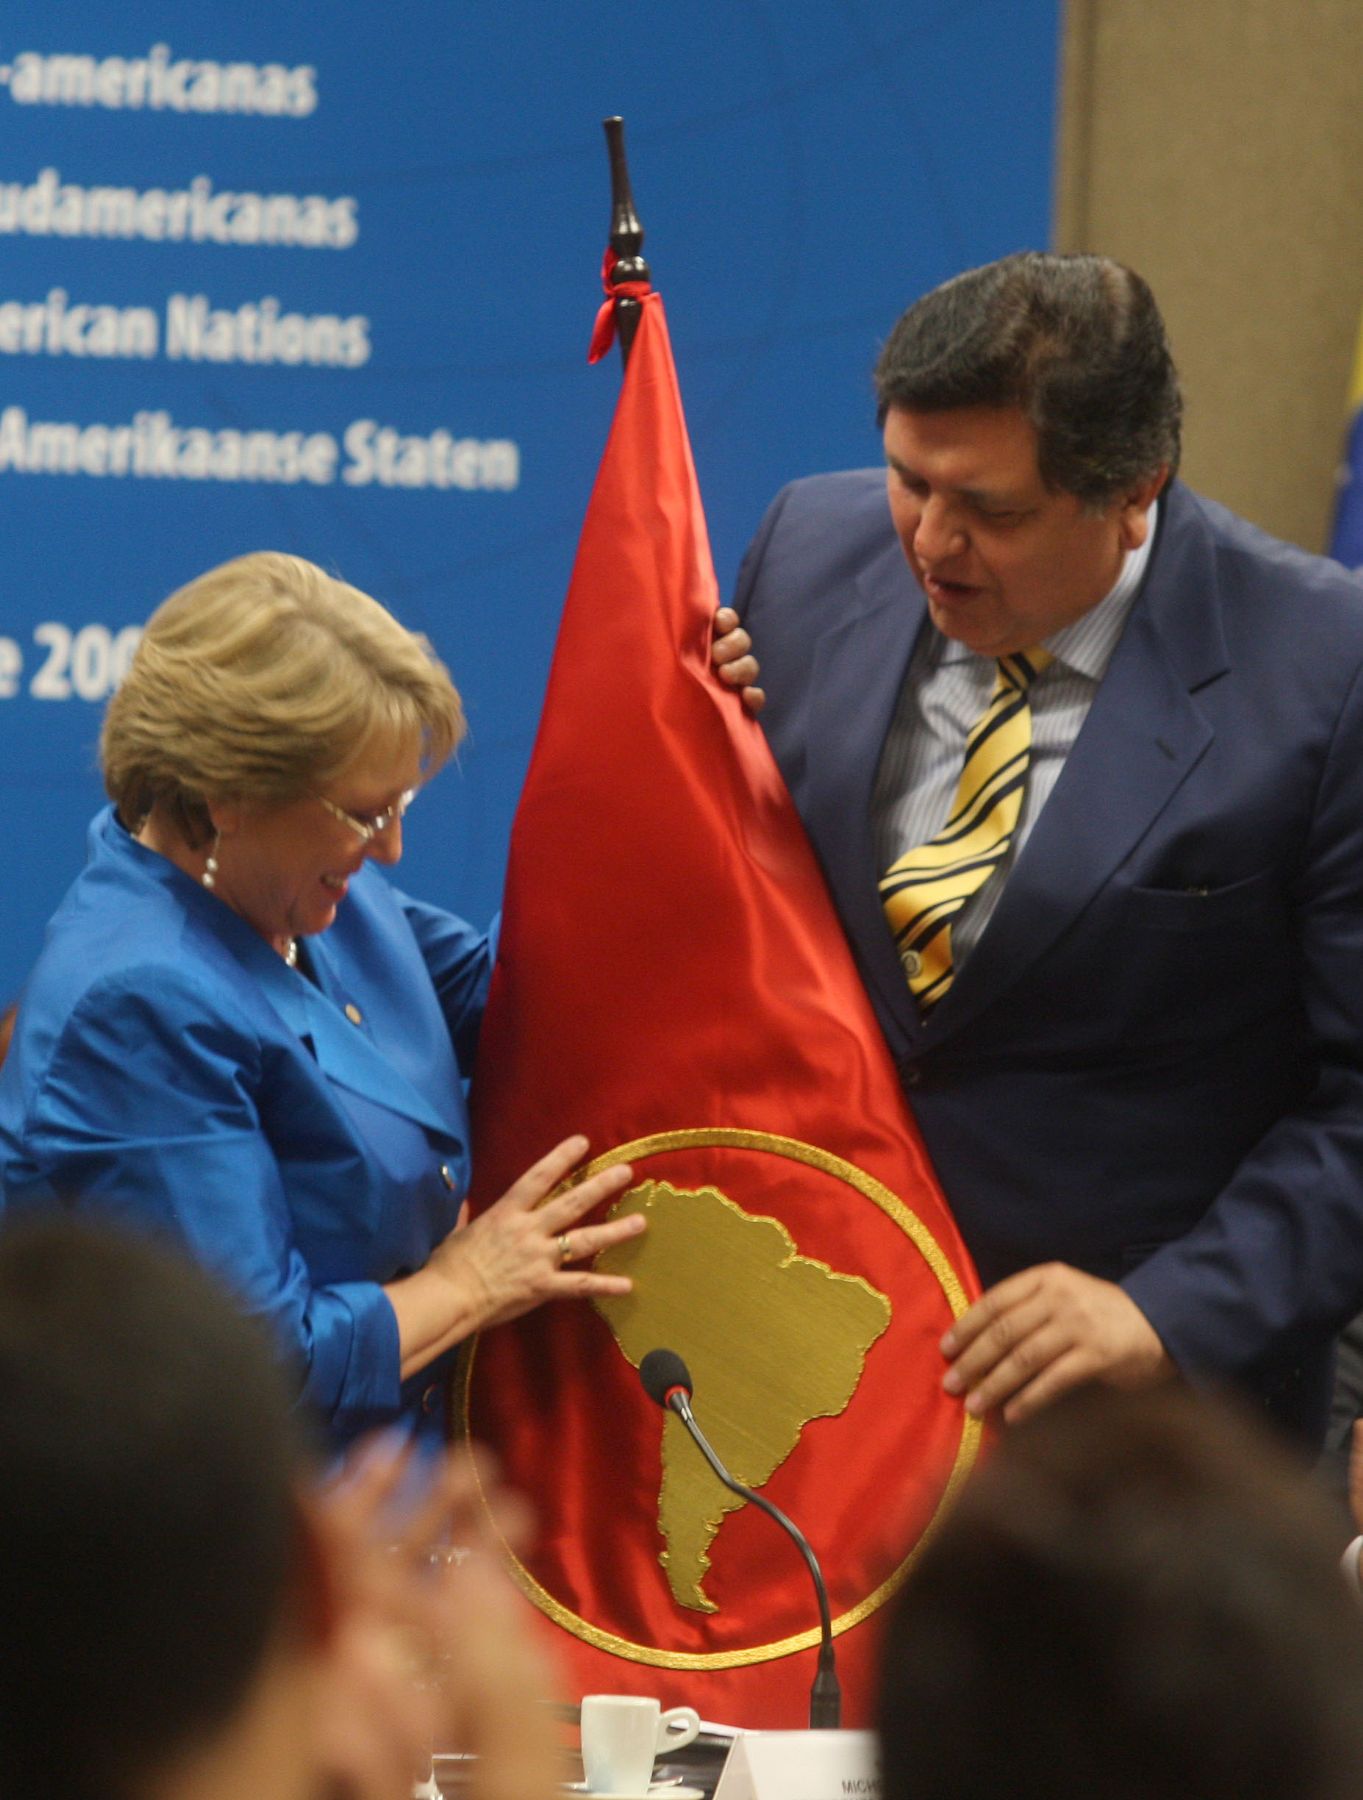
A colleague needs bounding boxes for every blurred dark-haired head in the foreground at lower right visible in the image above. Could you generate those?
[880,1388,1363,1800]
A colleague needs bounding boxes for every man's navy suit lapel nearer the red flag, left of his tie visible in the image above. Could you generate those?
[798,538,927,1039]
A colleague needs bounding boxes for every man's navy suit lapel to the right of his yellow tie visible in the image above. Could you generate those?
[924,490,1228,1044]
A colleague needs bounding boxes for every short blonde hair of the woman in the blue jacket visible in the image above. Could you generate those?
[99,551,465,844]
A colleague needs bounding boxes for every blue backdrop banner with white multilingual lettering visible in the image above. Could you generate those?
[0,0,1059,1001]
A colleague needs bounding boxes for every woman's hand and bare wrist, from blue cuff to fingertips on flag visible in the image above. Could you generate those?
[384,1138,645,1381]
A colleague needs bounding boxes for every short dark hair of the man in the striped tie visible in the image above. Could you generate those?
[875,250,1183,506]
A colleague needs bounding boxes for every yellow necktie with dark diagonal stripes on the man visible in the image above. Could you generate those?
[880,650,1052,1012]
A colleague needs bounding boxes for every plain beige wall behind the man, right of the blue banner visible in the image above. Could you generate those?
[1055,0,1363,549]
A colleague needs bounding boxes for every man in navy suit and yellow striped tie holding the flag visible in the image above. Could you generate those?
[736,254,1363,1438]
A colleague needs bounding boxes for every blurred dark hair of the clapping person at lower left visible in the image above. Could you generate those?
[0,1219,297,1800]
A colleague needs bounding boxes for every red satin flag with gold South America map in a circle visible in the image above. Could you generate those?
[463,280,978,1726]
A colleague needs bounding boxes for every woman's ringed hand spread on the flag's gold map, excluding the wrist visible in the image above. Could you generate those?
[427,1138,645,1330]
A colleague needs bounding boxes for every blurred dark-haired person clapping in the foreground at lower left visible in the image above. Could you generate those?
[0,1217,558,1800]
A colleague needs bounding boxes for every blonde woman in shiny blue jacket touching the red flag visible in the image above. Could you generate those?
[0,553,643,1442]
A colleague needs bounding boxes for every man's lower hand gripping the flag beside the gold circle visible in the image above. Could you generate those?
[942,1262,1174,1424]
